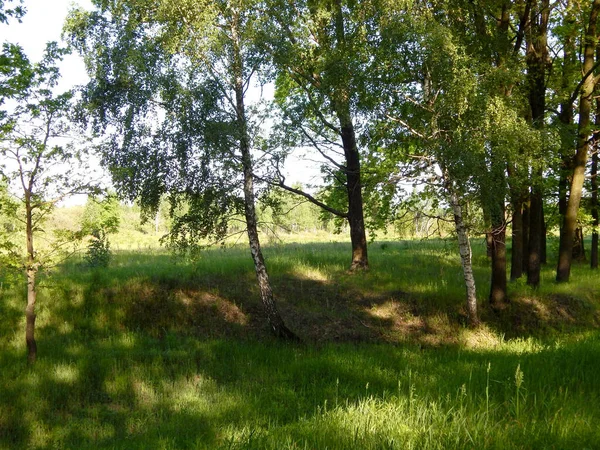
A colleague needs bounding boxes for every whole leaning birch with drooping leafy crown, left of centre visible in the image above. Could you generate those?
[67,0,296,339]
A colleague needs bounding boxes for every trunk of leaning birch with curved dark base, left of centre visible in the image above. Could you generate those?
[231,10,298,340]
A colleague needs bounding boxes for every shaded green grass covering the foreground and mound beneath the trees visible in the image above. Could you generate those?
[0,237,600,449]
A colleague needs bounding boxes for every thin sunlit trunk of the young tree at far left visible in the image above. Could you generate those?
[25,195,37,364]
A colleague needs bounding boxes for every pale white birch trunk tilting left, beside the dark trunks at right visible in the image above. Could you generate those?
[446,176,479,327]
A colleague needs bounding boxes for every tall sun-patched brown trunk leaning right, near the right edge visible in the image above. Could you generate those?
[556,0,600,282]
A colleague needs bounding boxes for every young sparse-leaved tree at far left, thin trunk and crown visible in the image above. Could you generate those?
[0,43,97,363]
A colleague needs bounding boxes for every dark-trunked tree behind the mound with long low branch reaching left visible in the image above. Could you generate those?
[264,0,376,270]
